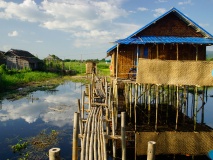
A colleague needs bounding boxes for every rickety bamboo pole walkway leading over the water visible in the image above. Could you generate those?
[72,75,126,160]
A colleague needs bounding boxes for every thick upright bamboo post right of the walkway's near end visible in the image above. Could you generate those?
[121,112,126,160]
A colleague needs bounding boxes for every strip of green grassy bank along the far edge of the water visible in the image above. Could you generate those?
[0,62,109,92]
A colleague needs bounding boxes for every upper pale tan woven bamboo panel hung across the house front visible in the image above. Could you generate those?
[136,58,213,86]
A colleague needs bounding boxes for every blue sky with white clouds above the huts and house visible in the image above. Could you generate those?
[0,0,213,60]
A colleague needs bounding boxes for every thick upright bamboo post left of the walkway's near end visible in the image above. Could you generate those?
[72,112,79,160]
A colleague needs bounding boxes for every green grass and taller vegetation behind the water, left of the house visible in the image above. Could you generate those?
[0,60,110,92]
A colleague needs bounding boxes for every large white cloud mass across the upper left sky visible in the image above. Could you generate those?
[0,0,133,46]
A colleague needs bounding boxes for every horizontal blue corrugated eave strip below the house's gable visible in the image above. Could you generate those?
[116,36,213,45]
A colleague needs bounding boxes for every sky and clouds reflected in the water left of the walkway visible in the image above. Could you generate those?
[0,82,82,159]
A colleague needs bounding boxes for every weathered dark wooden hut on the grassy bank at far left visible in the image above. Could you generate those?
[5,49,42,70]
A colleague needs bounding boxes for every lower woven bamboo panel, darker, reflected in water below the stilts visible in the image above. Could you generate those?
[135,132,213,155]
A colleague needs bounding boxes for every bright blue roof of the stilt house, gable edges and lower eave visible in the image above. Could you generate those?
[107,8,213,53]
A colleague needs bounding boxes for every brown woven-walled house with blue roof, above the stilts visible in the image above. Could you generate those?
[107,8,213,78]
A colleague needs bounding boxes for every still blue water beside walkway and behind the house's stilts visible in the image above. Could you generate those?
[0,82,213,160]
